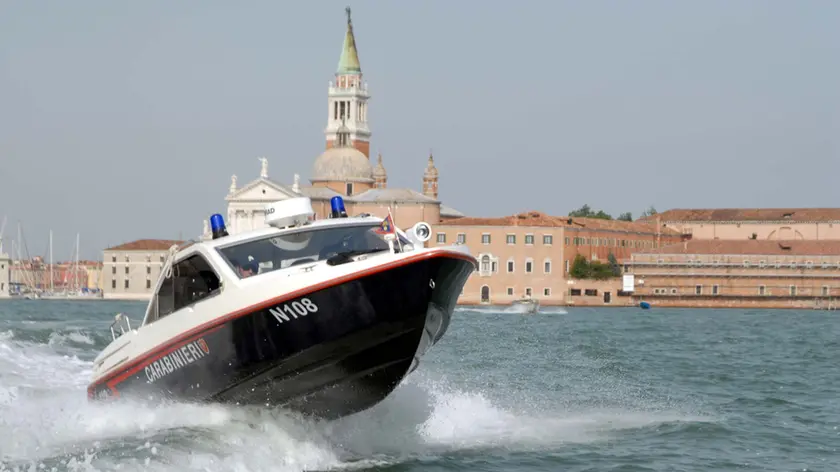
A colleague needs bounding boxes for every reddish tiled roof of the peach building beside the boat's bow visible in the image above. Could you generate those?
[437,211,679,235]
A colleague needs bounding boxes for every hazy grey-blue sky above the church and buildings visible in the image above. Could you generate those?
[0,0,840,259]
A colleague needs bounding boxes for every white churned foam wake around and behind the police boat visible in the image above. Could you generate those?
[0,328,711,472]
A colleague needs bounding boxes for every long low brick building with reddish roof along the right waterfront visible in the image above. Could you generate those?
[624,240,840,309]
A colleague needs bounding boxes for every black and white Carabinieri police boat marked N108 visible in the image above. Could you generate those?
[87,197,477,419]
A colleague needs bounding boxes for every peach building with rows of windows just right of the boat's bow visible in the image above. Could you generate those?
[430,211,681,305]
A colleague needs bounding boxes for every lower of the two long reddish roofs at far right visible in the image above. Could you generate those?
[636,239,840,256]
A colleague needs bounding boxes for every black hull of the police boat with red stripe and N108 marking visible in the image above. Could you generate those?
[88,253,475,418]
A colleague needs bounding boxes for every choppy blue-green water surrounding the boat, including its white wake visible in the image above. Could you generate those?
[0,301,840,472]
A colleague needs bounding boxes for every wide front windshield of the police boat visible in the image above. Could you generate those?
[218,223,410,278]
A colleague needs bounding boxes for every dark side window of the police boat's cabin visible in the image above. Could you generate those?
[149,254,221,323]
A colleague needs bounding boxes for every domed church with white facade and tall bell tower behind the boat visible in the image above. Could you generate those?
[202,8,464,239]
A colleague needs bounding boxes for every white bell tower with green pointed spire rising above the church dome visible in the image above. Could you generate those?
[324,7,370,159]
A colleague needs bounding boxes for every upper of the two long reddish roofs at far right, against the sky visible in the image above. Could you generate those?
[640,208,840,221]
